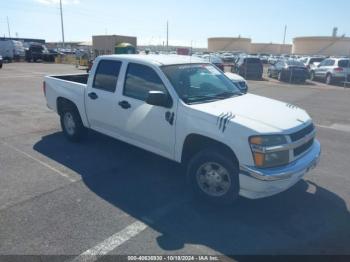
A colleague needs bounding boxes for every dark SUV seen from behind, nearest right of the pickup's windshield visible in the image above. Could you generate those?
[234,57,263,79]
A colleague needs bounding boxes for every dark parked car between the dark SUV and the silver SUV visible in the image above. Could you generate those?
[267,60,309,83]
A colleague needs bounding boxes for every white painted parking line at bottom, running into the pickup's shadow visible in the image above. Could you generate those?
[68,197,186,262]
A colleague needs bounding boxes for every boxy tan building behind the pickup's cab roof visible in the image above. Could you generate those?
[92,35,137,56]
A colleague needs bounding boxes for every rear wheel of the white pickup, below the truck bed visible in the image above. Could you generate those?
[60,108,86,142]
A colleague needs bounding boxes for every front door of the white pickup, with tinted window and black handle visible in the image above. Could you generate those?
[116,63,177,158]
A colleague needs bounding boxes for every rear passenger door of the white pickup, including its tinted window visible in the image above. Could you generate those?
[85,59,122,136]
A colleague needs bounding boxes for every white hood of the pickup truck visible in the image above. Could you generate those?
[190,94,311,132]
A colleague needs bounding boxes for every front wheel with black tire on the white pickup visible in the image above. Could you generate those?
[187,148,239,205]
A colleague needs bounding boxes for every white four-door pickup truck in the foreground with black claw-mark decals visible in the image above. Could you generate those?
[43,55,321,203]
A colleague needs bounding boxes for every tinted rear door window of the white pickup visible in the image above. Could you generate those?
[92,60,122,93]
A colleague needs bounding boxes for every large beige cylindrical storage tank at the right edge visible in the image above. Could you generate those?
[293,36,350,56]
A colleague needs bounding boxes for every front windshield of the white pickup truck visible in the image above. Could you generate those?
[161,64,241,104]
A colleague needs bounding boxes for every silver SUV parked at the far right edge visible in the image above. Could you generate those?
[310,58,350,85]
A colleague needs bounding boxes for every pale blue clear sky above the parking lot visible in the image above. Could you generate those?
[0,0,350,47]
